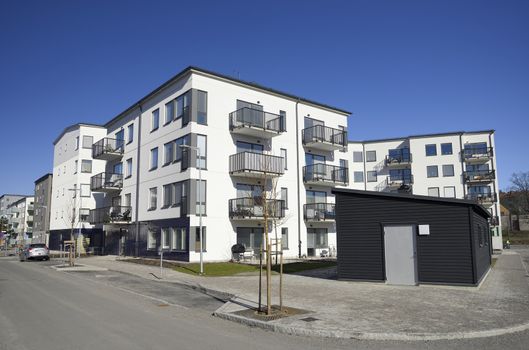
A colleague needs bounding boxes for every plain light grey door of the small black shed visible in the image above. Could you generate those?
[384,225,417,286]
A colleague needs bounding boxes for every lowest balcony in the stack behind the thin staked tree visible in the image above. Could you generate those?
[228,197,285,221]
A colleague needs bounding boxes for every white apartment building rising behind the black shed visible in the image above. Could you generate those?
[348,130,503,249]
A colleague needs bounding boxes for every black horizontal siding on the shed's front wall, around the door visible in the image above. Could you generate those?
[336,193,474,284]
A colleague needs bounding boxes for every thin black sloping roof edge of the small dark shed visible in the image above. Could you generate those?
[331,188,491,218]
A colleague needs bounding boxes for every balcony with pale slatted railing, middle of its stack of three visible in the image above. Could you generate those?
[230,152,285,178]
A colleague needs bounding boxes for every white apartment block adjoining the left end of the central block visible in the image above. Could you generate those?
[49,124,106,252]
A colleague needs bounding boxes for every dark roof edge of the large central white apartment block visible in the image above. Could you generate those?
[105,66,351,127]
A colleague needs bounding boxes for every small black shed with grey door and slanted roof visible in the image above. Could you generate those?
[333,189,492,285]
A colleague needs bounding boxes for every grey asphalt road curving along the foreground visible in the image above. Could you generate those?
[0,254,529,350]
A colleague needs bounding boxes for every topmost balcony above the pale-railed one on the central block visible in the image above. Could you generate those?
[230,107,286,139]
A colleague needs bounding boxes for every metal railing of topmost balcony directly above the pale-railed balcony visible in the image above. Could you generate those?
[230,107,286,134]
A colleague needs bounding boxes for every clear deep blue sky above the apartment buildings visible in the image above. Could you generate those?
[0,0,529,193]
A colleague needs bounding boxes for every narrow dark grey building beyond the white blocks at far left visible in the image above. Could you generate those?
[33,174,53,244]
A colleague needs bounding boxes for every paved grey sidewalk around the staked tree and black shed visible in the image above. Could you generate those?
[77,248,529,340]
